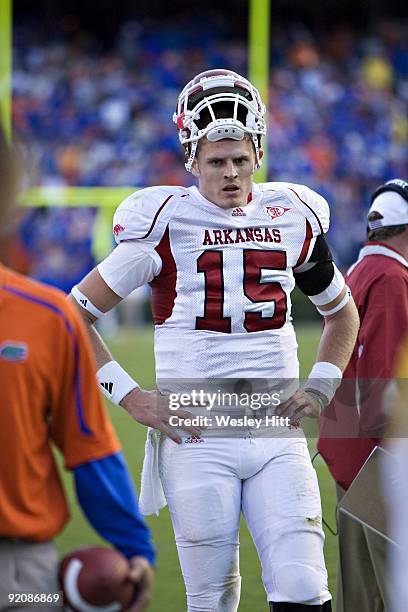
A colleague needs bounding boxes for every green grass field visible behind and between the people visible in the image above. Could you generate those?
[57,325,337,612]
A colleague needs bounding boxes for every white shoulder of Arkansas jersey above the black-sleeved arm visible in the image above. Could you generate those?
[259,182,330,236]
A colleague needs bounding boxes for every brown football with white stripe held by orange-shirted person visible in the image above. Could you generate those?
[59,546,135,612]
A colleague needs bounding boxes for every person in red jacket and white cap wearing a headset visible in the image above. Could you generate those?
[318,179,408,612]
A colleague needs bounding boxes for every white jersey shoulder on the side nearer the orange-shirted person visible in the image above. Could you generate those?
[113,187,182,244]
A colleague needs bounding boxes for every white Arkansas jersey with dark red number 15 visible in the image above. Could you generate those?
[98,183,329,379]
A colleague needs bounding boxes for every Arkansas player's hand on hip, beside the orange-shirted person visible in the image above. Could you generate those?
[120,388,201,444]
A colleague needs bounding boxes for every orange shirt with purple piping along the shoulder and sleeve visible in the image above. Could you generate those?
[0,265,119,541]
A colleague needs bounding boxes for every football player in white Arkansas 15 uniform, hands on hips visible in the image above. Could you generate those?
[72,69,358,612]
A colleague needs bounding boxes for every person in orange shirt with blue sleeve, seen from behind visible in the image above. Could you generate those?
[0,133,154,612]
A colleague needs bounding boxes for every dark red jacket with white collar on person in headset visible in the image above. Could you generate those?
[317,242,408,489]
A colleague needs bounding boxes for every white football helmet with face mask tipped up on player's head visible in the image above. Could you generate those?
[173,68,266,172]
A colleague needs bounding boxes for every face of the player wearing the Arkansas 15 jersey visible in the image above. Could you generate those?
[192,138,262,208]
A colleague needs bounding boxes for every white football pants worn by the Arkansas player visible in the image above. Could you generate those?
[160,437,331,612]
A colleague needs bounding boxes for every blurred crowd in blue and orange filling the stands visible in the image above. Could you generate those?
[7,17,408,288]
